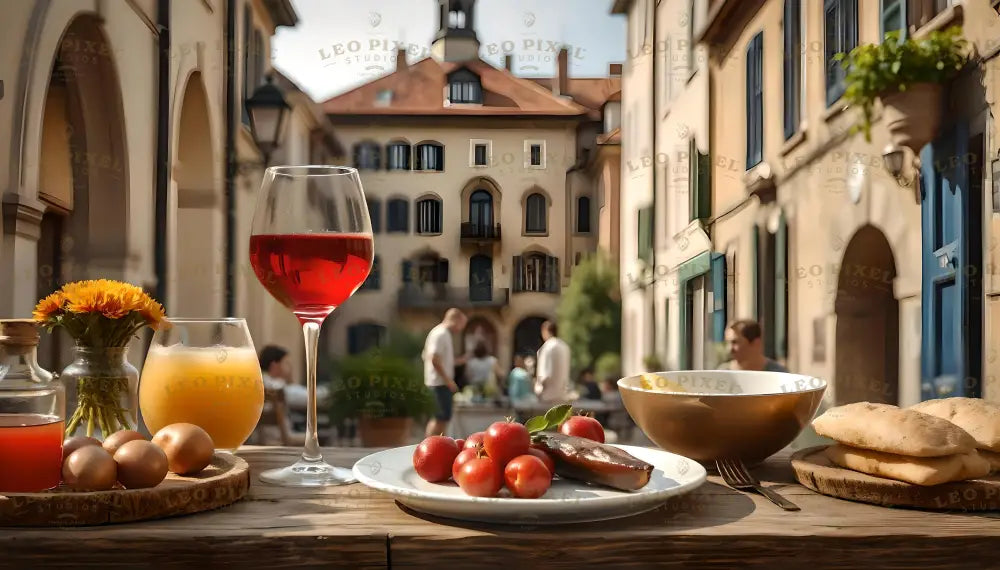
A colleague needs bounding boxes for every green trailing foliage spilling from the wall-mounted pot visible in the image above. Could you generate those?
[834,26,969,142]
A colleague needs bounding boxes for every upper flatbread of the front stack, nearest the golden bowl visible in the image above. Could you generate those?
[813,402,976,457]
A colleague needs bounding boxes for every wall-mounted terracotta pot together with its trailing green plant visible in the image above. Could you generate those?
[836,26,969,153]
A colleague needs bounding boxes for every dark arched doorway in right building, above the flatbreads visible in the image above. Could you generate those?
[834,225,899,405]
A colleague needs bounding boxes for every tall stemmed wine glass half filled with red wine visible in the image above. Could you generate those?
[250,166,374,487]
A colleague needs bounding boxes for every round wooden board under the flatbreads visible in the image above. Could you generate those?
[791,445,1000,511]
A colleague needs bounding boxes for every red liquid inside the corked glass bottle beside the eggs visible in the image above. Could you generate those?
[0,414,64,493]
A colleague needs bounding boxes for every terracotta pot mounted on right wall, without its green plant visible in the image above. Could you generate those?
[880,83,944,155]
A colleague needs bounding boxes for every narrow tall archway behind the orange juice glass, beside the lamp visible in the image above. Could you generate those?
[167,71,225,317]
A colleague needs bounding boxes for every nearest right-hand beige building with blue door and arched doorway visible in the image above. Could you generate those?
[700,0,1000,405]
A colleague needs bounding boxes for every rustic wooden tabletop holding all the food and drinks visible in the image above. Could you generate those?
[0,447,1000,570]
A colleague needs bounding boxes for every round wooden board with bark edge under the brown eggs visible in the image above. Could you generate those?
[0,453,250,527]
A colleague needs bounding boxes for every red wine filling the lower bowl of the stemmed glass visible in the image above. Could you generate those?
[250,233,375,323]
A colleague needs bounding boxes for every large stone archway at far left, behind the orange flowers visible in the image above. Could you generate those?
[35,15,129,368]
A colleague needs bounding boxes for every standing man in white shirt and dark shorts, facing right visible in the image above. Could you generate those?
[422,308,468,437]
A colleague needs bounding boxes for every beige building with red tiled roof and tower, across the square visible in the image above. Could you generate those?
[323,0,620,367]
